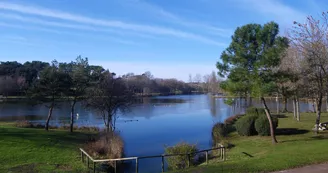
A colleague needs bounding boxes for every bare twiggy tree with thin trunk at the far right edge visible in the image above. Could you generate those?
[290,12,328,132]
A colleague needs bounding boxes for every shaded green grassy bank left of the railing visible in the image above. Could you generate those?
[0,123,92,173]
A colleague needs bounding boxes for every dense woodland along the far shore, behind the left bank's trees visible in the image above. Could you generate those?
[0,57,220,96]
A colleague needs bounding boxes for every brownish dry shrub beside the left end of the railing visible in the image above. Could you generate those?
[85,132,124,164]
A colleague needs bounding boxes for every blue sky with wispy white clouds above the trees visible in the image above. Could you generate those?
[0,0,328,81]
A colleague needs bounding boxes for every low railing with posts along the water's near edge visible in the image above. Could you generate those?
[80,145,226,173]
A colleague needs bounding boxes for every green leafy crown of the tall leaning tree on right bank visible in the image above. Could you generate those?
[217,22,288,96]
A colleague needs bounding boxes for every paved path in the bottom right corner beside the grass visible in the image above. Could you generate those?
[273,163,328,173]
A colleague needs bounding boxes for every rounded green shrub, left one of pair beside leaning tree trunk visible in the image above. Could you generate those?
[235,115,258,136]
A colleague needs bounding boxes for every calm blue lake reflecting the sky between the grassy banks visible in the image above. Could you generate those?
[0,95,320,172]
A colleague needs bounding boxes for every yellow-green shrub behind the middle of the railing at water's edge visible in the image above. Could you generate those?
[165,142,198,170]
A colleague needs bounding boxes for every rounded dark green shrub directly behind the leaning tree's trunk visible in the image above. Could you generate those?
[255,115,278,136]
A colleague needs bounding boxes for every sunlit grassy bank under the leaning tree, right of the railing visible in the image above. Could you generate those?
[178,113,328,173]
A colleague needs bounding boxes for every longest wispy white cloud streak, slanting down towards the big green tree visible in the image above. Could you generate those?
[0,1,225,46]
